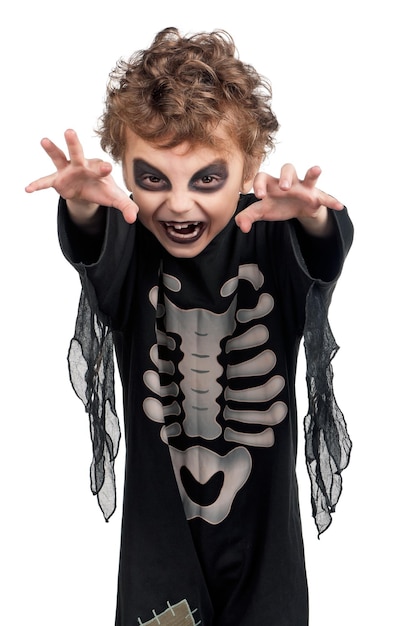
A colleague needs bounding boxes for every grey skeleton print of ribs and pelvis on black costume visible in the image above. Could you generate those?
[143,264,287,524]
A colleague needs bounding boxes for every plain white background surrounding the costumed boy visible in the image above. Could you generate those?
[0,0,416,626]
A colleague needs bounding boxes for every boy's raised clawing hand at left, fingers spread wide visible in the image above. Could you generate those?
[26,130,138,223]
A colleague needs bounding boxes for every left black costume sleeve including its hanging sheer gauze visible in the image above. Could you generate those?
[58,199,136,520]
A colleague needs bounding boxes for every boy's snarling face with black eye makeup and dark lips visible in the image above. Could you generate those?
[123,129,254,258]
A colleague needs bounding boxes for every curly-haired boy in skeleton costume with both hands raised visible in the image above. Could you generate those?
[27,28,352,626]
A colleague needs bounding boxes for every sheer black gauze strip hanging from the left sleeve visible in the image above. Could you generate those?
[68,286,120,521]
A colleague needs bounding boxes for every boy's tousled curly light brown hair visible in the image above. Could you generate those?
[97,28,279,175]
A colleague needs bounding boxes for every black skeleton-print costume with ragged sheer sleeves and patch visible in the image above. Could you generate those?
[59,194,353,626]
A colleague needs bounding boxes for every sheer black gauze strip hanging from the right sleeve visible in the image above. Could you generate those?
[304,283,352,536]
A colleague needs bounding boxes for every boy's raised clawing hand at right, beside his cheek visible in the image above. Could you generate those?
[236,164,344,235]
